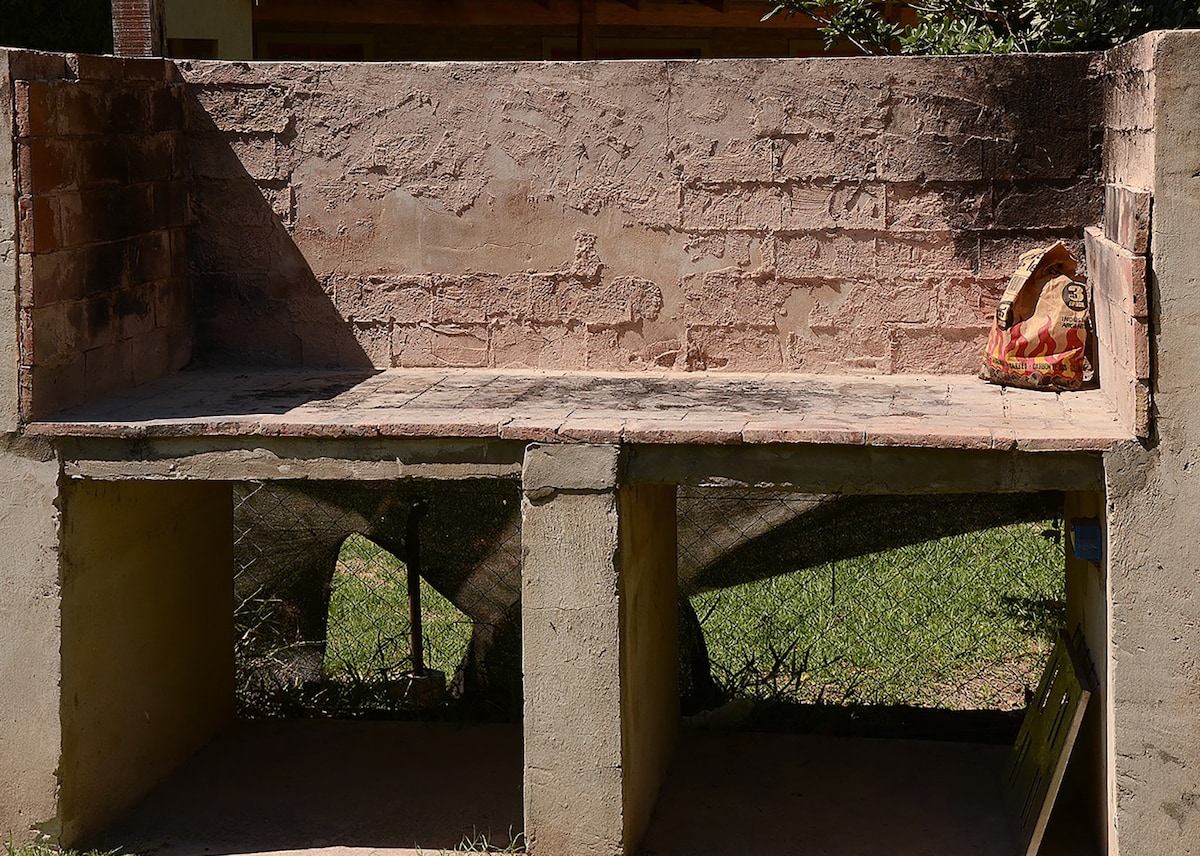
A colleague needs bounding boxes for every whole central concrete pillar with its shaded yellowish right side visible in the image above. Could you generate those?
[522,445,679,856]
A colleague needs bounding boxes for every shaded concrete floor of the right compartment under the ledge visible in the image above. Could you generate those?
[641,731,1094,856]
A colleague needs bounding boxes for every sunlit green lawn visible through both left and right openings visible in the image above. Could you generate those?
[243,513,1064,710]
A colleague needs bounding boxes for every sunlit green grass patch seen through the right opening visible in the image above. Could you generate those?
[694,513,1064,710]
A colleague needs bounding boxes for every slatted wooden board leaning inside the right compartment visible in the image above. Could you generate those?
[1004,633,1091,856]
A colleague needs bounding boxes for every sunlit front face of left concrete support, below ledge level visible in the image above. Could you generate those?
[0,437,59,843]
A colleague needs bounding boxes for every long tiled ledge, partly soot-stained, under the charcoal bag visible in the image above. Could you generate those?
[25,369,1133,451]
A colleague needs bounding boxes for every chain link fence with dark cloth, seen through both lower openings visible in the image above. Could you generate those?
[234,480,1064,718]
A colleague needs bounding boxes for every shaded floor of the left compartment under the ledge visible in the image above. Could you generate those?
[101,719,522,856]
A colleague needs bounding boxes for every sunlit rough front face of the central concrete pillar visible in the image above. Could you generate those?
[521,445,624,856]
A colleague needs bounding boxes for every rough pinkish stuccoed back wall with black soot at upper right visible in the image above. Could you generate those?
[180,55,1102,373]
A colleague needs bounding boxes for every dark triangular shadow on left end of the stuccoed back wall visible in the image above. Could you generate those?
[186,91,372,369]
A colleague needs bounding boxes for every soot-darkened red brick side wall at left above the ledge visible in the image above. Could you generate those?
[10,53,193,419]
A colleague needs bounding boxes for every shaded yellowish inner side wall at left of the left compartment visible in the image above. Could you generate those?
[52,481,234,846]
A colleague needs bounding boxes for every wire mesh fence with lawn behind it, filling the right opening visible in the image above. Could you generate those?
[679,490,1066,711]
